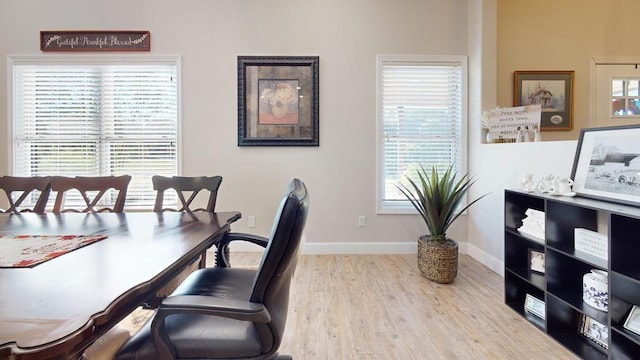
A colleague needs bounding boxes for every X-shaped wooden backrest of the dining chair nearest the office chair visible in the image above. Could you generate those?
[151,175,222,212]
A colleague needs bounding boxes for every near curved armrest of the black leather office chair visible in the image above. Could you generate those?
[151,295,271,359]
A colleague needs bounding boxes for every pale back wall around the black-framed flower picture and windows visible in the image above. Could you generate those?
[0,0,467,252]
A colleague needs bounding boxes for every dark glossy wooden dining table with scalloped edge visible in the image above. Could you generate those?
[0,212,240,360]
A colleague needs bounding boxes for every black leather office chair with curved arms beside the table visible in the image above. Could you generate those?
[115,179,309,360]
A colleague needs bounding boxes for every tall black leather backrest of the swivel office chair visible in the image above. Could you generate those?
[250,179,309,348]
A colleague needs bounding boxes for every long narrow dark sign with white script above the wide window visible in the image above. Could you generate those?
[40,31,151,51]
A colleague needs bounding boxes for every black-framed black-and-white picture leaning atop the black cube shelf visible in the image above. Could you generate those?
[571,125,640,206]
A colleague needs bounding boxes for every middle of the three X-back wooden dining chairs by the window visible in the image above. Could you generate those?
[51,175,131,214]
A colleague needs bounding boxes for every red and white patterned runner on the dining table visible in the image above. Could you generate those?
[0,234,107,268]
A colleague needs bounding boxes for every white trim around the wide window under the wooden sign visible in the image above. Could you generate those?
[6,54,183,210]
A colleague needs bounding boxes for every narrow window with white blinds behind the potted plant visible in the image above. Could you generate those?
[377,56,467,213]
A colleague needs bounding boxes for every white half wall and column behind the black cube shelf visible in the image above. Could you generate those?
[466,0,577,274]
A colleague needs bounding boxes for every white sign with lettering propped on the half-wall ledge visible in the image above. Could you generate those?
[489,104,542,140]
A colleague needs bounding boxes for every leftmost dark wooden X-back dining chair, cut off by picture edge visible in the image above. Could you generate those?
[0,176,51,214]
